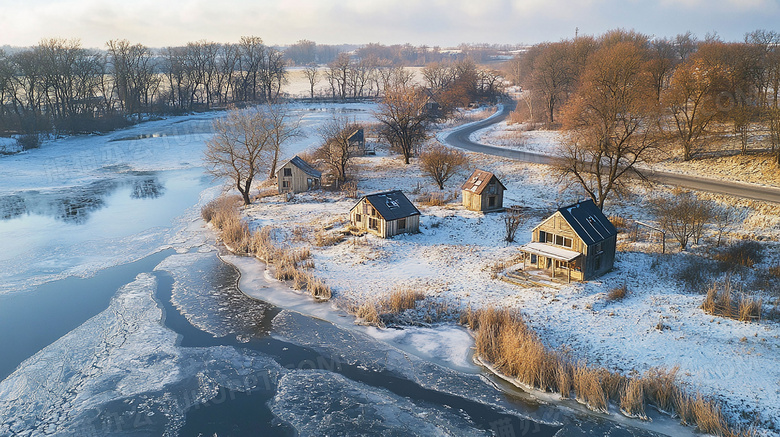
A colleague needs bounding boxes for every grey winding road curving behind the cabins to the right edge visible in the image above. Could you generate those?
[444,102,780,204]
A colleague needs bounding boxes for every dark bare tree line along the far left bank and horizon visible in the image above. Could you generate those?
[0,36,512,147]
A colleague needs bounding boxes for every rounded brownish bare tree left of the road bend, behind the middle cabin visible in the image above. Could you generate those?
[374,86,429,164]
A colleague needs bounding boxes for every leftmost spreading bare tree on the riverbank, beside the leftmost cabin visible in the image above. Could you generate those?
[204,108,273,205]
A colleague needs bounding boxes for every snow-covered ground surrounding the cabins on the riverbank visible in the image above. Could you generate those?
[244,125,780,435]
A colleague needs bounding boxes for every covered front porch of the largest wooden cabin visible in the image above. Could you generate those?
[520,242,582,282]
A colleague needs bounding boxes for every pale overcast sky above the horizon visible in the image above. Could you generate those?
[0,0,780,48]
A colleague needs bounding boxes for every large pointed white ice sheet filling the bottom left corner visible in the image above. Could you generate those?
[0,273,281,435]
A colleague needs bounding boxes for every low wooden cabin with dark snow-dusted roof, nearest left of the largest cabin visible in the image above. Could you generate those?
[349,190,420,238]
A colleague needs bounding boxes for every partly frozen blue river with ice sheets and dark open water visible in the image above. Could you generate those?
[0,105,672,436]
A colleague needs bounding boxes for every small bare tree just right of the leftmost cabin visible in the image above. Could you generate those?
[317,116,360,185]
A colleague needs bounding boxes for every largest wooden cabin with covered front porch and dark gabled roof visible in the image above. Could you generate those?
[520,199,617,281]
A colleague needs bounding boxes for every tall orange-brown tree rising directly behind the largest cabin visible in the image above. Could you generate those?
[559,42,658,209]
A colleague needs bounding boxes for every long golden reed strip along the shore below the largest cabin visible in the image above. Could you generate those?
[460,307,752,437]
